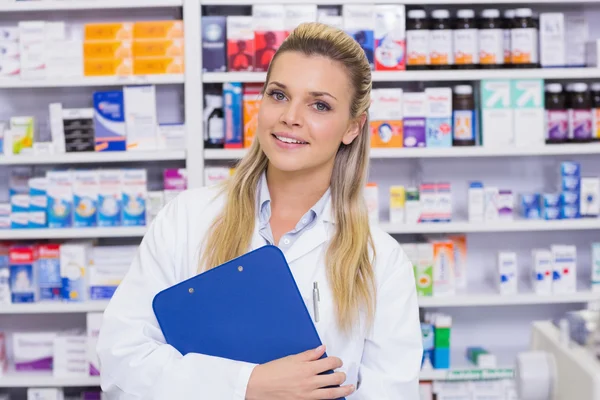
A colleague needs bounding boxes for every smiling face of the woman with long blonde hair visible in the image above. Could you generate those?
[257,52,360,172]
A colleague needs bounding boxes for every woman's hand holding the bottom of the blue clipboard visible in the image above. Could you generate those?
[246,346,354,400]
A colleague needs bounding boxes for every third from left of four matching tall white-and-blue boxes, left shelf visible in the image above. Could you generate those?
[98,169,123,227]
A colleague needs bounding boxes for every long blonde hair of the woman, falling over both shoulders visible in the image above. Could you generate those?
[200,23,376,332]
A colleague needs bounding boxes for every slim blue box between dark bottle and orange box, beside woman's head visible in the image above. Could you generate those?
[223,82,244,149]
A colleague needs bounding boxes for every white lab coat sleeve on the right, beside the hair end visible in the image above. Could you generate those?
[352,243,423,400]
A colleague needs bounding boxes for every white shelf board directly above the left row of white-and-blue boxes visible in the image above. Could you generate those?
[0,150,185,165]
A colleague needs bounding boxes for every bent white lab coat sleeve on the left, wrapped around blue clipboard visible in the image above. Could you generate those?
[97,195,255,400]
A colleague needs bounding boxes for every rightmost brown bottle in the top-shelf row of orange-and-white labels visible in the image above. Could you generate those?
[510,8,539,68]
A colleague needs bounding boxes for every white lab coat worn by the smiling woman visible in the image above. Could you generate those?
[97,188,422,400]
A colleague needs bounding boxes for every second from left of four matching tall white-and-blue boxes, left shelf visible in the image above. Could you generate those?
[73,170,100,228]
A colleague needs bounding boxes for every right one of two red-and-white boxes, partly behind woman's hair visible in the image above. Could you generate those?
[252,4,287,72]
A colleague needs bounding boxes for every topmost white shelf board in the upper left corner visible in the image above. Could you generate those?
[0,0,183,12]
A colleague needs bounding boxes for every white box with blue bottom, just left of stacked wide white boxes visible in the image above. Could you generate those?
[60,243,91,302]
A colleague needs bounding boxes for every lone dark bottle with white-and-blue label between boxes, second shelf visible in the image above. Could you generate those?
[452,85,477,146]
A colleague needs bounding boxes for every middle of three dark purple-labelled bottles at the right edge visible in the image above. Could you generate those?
[569,83,592,142]
